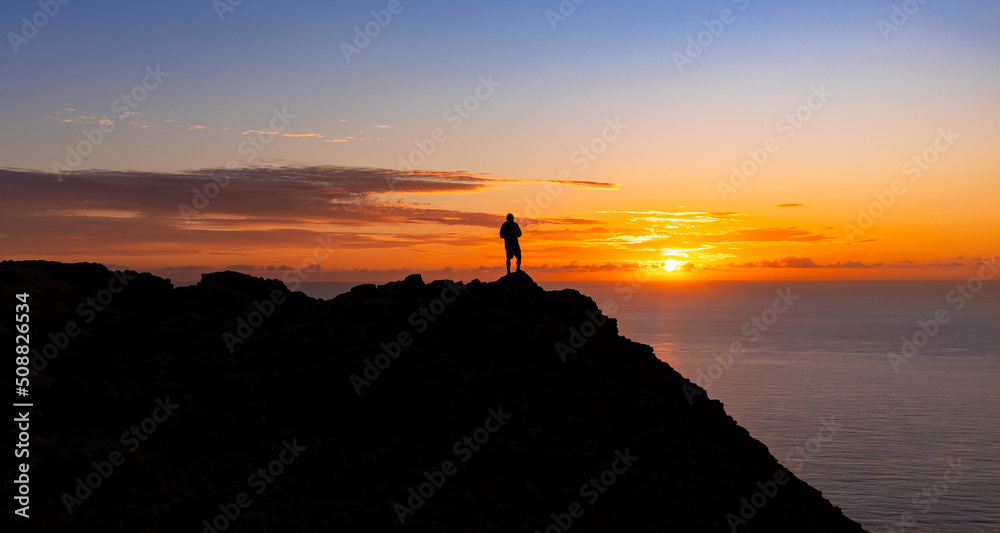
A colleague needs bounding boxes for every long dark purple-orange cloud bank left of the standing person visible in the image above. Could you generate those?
[0,166,606,256]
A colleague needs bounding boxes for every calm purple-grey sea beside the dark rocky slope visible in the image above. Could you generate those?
[302,279,1000,533]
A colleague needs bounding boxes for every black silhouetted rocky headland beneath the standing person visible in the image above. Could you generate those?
[0,261,863,533]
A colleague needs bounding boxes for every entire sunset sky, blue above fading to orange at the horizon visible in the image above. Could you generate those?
[0,0,1000,282]
